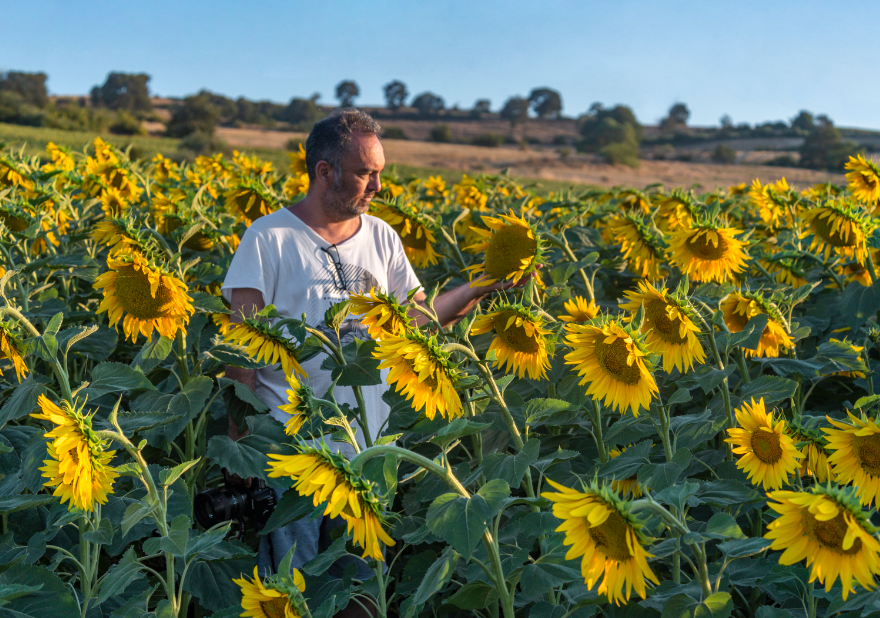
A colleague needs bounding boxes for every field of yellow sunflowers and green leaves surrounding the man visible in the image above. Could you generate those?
[0,139,880,618]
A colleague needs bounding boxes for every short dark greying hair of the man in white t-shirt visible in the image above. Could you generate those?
[306,107,382,182]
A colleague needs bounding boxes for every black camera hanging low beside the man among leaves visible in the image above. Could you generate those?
[193,479,278,530]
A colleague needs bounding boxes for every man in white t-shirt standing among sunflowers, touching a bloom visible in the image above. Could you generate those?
[223,109,510,609]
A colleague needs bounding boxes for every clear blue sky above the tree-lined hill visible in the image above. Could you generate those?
[0,0,880,129]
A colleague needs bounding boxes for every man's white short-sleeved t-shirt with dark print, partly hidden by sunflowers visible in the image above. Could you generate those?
[223,208,421,457]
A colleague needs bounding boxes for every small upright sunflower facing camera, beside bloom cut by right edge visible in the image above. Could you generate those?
[724,397,803,491]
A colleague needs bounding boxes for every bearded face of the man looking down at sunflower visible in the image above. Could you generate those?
[324,133,385,221]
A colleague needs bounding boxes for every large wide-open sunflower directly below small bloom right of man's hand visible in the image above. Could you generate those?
[565,318,658,416]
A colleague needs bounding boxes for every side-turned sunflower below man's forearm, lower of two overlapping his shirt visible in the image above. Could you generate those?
[373,330,462,420]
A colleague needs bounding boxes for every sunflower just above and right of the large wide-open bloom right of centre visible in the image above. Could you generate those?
[620,281,706,373]
